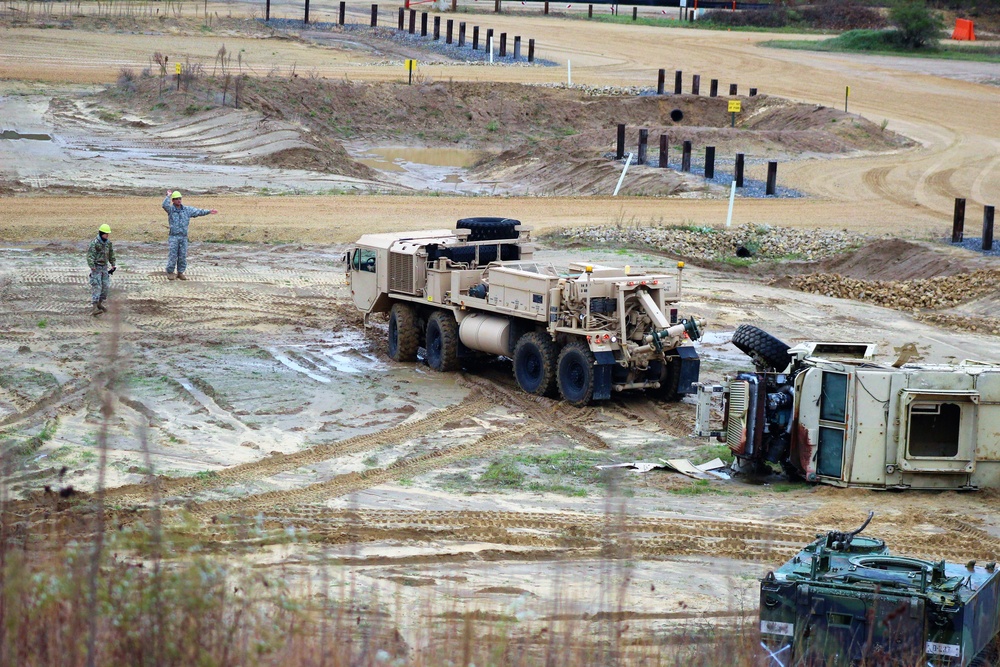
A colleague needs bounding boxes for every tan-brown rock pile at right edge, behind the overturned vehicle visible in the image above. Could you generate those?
[790,269,1000,310]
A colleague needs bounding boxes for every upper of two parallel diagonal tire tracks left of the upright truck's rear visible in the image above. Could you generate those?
[106,394,492,504]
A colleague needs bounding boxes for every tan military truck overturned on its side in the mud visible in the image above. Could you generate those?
[695,325,1000,489]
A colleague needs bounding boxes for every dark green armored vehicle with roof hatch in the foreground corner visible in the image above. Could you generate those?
[760,513,1000,667]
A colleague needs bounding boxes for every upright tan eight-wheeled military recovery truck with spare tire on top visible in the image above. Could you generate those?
[346,218,700,406]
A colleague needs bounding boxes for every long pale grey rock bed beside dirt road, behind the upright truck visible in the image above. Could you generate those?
[557,221,870,263]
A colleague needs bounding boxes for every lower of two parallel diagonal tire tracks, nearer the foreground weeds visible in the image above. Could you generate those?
[191,426,538,520]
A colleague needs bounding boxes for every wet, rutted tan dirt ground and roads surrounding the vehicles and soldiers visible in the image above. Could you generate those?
[0,4,1000,656]
